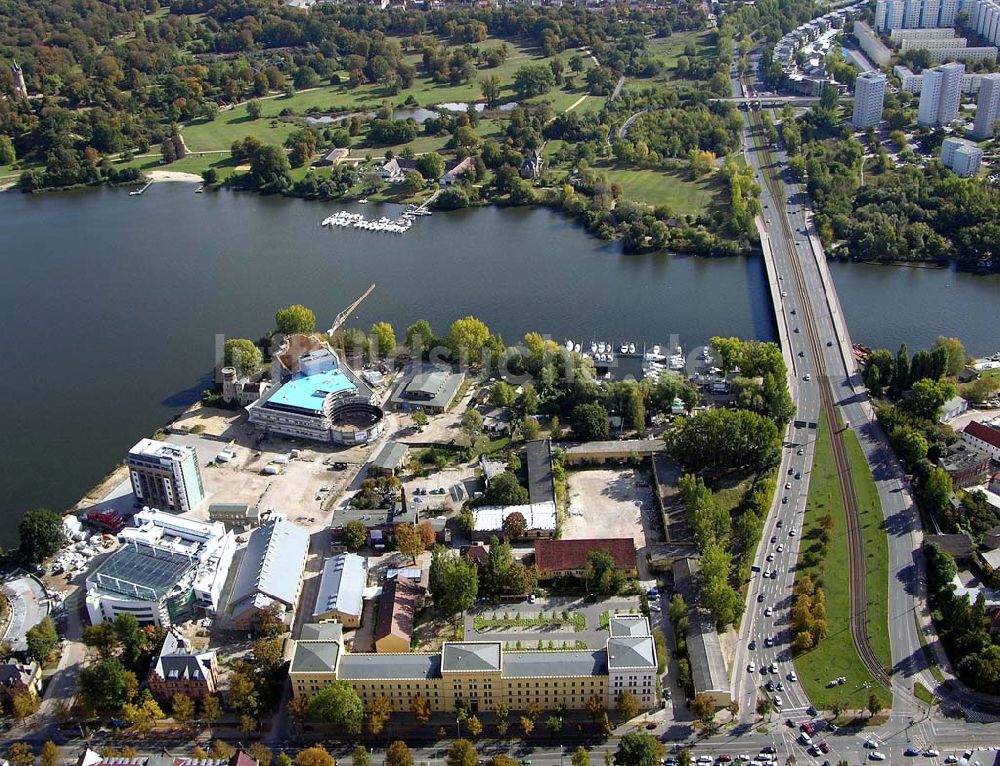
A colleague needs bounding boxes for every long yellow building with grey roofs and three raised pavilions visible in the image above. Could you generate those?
[288,615,657,713]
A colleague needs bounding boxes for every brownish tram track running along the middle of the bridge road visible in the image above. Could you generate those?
[744,93,892,688]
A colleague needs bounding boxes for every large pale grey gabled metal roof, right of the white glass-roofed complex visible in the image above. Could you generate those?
[230,519,309,613]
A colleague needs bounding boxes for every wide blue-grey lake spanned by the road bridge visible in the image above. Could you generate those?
[0,183,1000,547]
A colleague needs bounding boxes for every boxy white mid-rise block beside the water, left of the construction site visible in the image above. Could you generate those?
[127,439,205,513]
